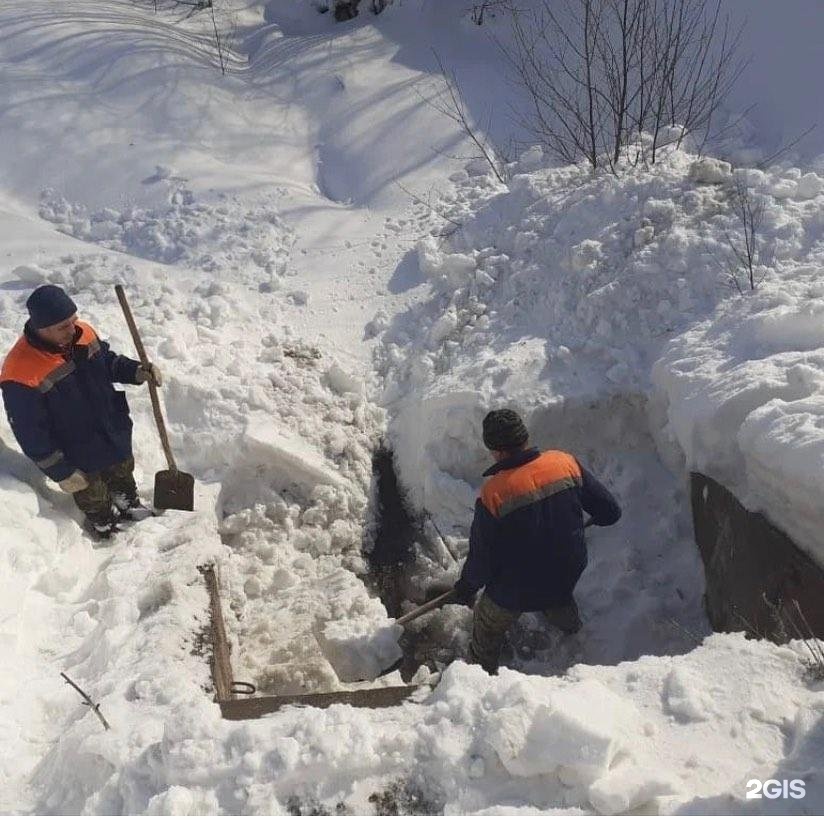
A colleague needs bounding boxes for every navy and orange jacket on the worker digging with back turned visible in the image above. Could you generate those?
[456,448,621,612]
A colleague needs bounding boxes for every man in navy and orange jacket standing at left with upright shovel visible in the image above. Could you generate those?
[0,285,161,538]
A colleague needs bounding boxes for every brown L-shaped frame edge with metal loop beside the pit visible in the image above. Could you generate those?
[198,564,421,720]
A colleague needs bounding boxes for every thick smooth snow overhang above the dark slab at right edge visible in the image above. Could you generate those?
[653,260,824,563]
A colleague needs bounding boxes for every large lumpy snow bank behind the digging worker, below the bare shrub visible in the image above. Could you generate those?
[379,149,824,560]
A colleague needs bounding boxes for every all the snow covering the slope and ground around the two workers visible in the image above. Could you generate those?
[0,0,824,814]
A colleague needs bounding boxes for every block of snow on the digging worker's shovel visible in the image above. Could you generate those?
[317,619,403,682]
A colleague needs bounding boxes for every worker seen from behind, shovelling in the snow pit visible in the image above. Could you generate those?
[454,410,621,673]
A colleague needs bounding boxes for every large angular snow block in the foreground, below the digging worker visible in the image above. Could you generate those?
[489,680,641,785]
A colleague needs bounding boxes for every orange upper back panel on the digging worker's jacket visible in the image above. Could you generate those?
[481,450,581,518]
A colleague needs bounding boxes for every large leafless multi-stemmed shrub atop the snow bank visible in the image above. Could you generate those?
[502,0,746,172]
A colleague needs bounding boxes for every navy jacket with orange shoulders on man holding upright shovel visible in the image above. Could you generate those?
[0,322,138,481]
